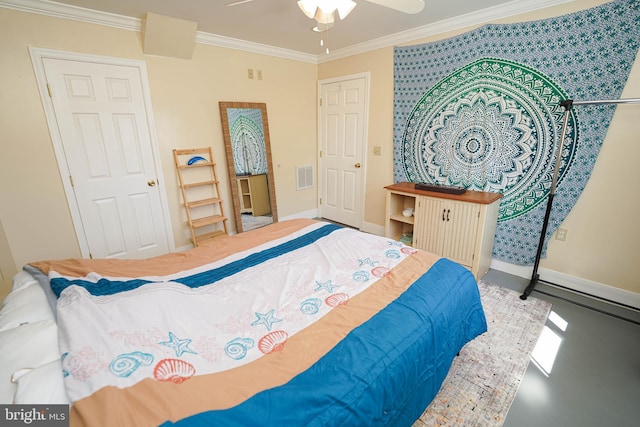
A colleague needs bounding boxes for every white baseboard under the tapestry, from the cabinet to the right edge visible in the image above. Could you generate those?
[491,259,640,310]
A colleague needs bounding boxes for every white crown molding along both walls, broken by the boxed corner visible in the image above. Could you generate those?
[0,0,575,64]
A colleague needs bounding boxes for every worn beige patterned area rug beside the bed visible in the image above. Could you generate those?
[413,281,551,427]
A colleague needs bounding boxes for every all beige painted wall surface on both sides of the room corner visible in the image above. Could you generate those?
[0,0,640,300]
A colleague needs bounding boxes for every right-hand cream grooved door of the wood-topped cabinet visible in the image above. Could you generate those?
[442,200,480,267]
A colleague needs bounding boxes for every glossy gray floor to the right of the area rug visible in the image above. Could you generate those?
[483,270,640,427]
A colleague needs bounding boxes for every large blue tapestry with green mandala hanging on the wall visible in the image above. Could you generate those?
[394,0,640,265]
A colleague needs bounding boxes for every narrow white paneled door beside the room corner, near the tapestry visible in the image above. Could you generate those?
[318,76,368,228]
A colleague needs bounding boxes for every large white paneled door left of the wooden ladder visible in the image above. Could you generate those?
[41,54,169,258]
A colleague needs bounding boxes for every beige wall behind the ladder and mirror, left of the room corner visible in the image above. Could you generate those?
[0,8,317,300]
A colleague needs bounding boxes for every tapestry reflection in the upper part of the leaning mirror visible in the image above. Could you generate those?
[227,108,267,175]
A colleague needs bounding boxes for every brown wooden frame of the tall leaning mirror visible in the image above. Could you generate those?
[219,101,278,233]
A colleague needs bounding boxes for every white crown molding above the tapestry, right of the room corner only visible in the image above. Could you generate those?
[318,0,576,63]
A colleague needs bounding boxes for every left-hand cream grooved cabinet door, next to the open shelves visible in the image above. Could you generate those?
[413,196,445,255]
